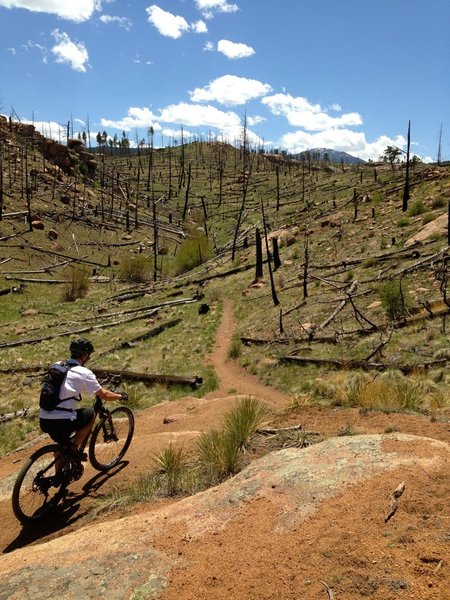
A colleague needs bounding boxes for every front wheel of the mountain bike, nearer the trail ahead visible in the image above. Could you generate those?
[89,406,134,471]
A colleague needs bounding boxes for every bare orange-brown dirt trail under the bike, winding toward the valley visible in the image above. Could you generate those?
[0,300,450,552]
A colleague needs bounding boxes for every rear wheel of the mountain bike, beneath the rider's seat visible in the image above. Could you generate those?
[12,444,65,523]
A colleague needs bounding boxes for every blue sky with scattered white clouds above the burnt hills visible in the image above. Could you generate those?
[0,0,450,161]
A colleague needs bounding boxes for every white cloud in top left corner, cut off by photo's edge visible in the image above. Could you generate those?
[0,0,101,23]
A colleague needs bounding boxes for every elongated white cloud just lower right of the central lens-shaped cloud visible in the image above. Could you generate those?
[261,94,362,131]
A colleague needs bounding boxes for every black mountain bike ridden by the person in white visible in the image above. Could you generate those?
[12,396,134,523]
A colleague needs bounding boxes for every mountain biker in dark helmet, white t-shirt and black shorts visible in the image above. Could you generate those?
[39,338,126,450]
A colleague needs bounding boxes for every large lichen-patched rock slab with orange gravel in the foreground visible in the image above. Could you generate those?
[0,433,450,600]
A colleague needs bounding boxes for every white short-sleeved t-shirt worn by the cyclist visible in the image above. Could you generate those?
[39,365,102,420]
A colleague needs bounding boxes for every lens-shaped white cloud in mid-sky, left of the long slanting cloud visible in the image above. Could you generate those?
[189,75,272,106]
